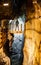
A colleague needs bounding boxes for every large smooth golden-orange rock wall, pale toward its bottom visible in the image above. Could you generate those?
[23,18,41,65]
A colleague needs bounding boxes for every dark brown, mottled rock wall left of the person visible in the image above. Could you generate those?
[0,20,10,65]
